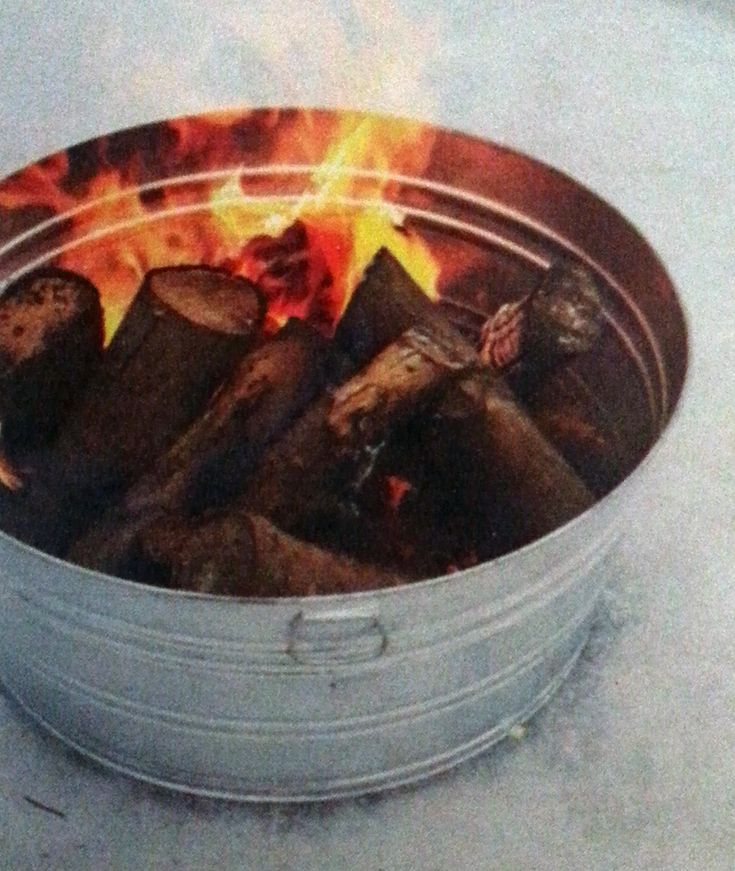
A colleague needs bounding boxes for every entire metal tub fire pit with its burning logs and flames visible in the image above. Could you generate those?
[0,110,686,800]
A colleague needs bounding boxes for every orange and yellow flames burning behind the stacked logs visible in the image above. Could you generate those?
[0,110,439,338]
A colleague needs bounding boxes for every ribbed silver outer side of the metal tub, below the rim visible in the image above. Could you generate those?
[0,494,617,801]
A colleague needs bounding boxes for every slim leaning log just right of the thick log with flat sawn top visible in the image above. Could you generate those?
[69,319,329,576]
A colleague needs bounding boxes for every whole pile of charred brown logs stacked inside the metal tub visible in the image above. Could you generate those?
[0,249,601,596]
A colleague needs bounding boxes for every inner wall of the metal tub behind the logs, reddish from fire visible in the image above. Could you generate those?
[0,110,687,548]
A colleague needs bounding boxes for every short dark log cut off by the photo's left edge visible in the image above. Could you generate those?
[0,268,103,456]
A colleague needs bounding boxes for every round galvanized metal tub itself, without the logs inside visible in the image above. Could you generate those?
[0,110,687,801]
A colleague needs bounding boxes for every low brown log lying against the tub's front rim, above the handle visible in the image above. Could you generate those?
[141,510,405,596]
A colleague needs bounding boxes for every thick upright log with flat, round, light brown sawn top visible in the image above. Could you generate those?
[2,266,264,554]
